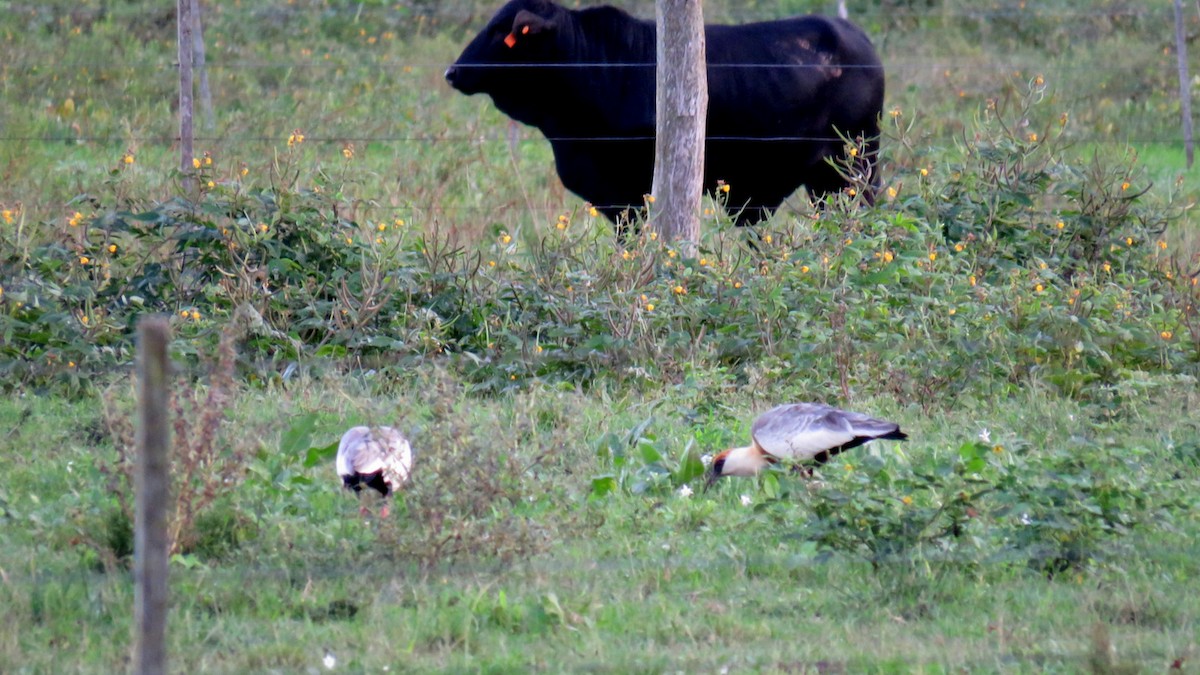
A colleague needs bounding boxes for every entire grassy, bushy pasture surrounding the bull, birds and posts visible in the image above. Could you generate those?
[0,0,1200,673]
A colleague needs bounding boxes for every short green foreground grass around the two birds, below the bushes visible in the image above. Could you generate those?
[0,382,1200,671]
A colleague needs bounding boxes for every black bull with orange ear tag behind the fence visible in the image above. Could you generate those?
[445,0,883,225]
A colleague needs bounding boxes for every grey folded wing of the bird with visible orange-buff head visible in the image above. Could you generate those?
[750,404,856,460]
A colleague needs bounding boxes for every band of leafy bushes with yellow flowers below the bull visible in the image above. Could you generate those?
[0,80,1200,405]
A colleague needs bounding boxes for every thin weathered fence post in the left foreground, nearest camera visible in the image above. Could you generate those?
[133,316,170,675]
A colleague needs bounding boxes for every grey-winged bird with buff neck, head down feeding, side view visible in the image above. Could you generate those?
[704,404,908,490]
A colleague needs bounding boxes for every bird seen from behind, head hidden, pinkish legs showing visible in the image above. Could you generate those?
[337,426,413,518]
